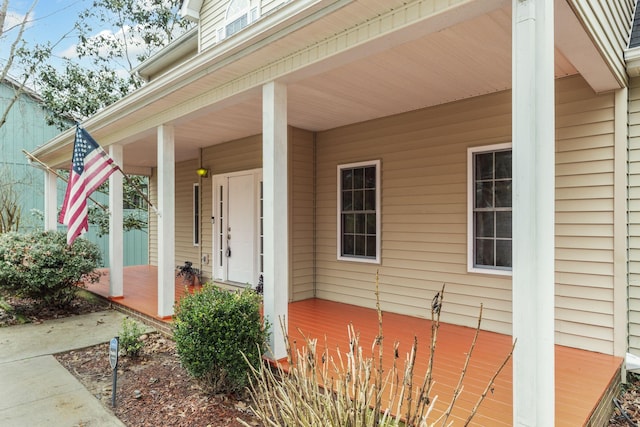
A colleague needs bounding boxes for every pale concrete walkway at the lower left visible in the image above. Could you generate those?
[0,310,129,427]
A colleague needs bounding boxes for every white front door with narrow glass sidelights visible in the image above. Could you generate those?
[213,171,260,285]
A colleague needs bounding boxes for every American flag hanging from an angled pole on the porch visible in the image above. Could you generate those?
[58,126,119,246]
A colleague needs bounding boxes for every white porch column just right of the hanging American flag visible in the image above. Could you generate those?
[109,144,124,297]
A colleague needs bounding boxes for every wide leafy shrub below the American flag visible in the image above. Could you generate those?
[0,231,102,306]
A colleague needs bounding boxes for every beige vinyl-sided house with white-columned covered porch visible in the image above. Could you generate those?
[34,0,640,426]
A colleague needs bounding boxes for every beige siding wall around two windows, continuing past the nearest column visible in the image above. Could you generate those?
[316,77,614,353]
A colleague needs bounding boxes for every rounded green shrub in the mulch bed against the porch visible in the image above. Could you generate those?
[173,284,266,393]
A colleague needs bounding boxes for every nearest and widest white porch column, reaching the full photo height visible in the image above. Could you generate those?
[512,0,555,426]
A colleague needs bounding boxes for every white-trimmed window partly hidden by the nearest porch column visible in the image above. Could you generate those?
[468,143,513,274]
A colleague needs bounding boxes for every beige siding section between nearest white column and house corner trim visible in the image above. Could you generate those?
[556,78,615,353]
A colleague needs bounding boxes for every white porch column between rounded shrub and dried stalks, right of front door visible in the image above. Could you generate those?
[262,82,289,360]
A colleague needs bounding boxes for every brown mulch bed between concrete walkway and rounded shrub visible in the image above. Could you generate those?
[56,333,259,427]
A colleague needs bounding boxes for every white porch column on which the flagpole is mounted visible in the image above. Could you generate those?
[158,125,176,317]
